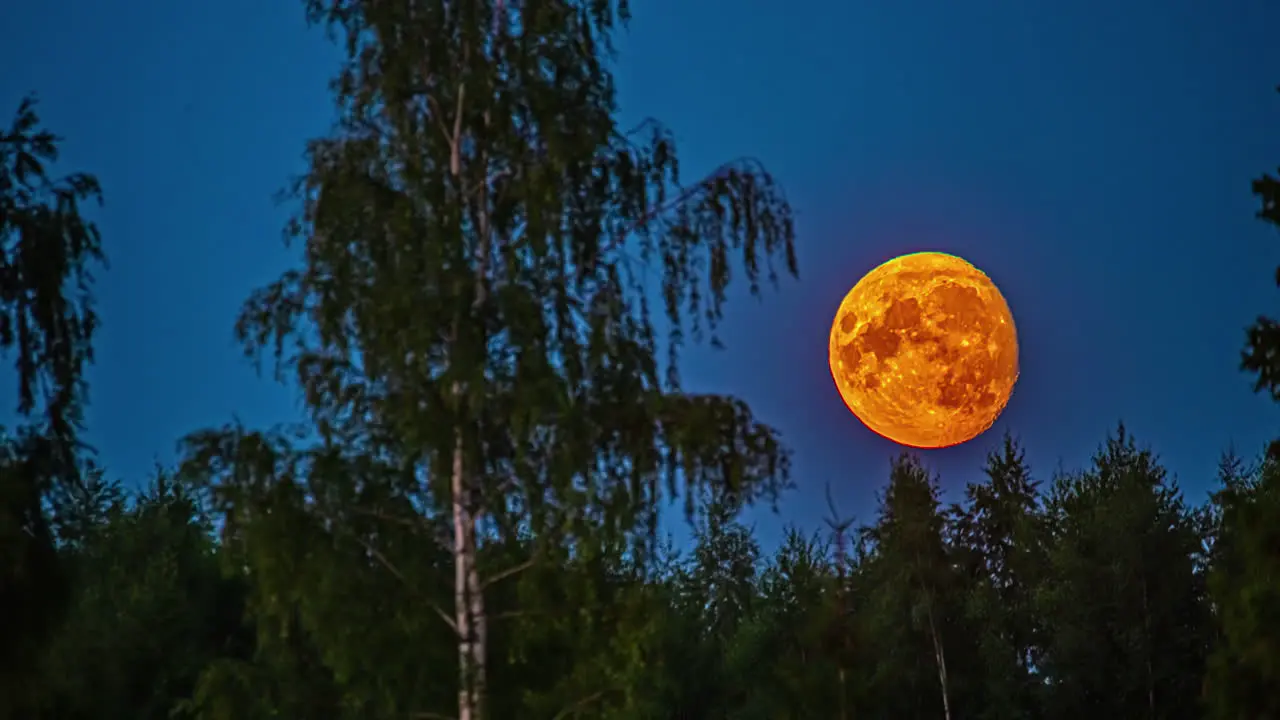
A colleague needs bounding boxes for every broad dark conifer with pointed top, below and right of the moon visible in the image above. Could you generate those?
[1038,425,1208,719]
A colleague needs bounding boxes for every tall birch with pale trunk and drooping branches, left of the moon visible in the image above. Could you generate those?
[181,0,796,720]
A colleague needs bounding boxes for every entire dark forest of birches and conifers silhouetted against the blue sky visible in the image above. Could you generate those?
[0,0,1280,720]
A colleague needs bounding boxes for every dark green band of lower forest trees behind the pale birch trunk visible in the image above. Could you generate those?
[10,428,1280,720]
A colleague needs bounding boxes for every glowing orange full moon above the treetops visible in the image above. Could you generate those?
[829,252,1018,447]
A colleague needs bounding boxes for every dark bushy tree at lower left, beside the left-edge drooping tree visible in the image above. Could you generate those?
[41,473,239,720]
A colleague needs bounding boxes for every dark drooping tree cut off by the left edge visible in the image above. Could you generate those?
[0,96,104,717]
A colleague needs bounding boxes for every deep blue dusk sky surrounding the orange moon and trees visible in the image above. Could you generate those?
[0,0,1280,534]
